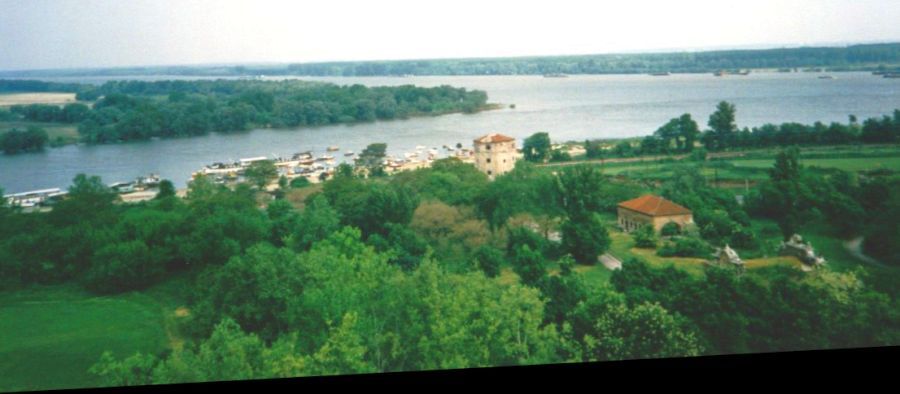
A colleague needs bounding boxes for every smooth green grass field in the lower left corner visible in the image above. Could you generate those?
[0,285,180,392]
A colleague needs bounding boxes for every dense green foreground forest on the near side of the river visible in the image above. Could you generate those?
[0,144,900,385]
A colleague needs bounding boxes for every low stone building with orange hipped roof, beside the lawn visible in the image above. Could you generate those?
[618,194,694,232]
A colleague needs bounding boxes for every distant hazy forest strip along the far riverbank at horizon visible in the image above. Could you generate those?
[0,43,900,78]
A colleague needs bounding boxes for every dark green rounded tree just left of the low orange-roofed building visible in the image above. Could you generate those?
[562,214,612,264]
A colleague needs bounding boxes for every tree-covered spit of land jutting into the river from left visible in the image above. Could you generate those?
[0,80,488,147]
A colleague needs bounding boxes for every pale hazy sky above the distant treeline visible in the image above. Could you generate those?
[0,0,900,70]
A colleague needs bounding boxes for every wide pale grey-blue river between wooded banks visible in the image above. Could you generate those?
[0,72,900,193]
